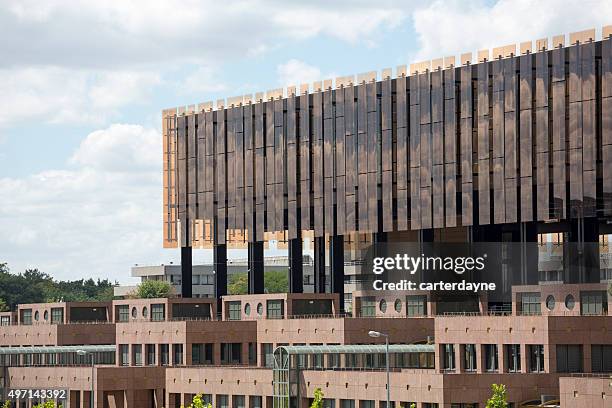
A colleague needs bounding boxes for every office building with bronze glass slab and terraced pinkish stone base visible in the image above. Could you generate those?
[0,27,612,408]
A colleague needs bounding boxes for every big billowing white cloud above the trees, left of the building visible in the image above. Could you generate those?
[0,124,176,281]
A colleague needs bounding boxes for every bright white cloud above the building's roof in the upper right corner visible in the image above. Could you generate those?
[412,0,612,61]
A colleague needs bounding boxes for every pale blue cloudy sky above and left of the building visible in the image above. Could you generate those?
[0,0,612,283]
